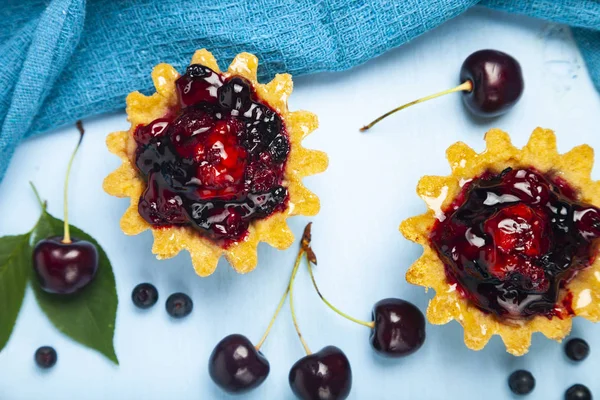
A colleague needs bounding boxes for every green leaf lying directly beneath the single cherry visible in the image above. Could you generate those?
[32,210,119,364]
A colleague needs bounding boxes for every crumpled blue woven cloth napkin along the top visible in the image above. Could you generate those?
[0,0,600,180]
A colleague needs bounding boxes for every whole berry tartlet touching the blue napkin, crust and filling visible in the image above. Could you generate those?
[104,50,327,276]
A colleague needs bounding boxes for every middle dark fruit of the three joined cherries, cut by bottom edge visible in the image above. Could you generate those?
[289,346,352,400]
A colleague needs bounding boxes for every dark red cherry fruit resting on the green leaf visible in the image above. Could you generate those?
[33,236,98,294]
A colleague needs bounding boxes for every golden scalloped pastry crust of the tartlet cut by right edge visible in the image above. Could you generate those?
[400,128,600,356]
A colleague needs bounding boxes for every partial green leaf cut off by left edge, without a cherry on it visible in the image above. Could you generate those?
[0,233,32,351]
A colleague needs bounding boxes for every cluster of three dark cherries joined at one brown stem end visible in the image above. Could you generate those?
[208,224,425,400]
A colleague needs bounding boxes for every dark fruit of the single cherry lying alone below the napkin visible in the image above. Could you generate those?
[460,50,525,117]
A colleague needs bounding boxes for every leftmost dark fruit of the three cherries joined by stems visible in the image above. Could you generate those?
[208,334,271,393]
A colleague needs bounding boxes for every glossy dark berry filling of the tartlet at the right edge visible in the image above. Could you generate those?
[430,168,600,318]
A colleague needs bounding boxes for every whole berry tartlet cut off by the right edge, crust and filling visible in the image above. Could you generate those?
[400,128,600,355]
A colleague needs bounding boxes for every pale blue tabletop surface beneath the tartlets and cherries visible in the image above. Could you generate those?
[0,9,600,400]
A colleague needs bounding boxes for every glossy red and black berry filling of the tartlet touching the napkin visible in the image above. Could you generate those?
[134,65,290,245]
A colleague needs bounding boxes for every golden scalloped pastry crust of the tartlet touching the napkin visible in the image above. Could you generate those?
[103,49,328,276]
